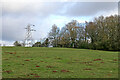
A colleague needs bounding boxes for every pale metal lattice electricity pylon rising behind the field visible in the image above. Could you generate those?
[24,24,36,47]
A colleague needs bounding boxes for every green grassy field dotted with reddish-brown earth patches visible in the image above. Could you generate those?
[2,47,118,78]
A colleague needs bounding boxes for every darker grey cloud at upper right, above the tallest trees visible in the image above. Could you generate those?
[63,2,118,16]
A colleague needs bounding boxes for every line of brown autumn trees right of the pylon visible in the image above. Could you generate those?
[14,15,120,51]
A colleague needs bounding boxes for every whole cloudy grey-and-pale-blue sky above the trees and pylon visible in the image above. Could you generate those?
[0,0,118,44]
